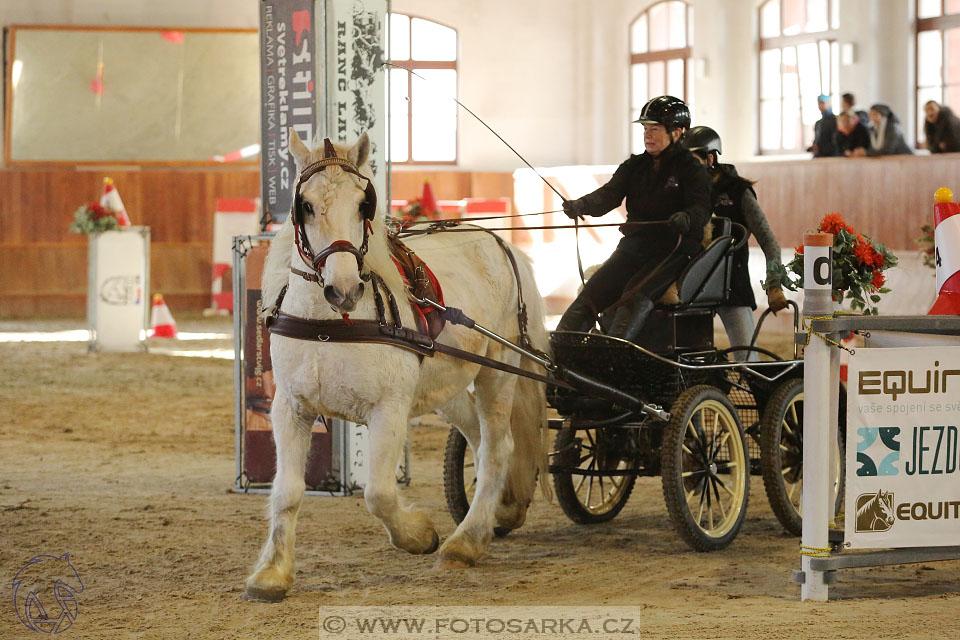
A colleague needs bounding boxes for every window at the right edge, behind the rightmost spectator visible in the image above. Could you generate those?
[917,0,960,148]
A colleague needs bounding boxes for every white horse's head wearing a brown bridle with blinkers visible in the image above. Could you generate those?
[290,129,376,313]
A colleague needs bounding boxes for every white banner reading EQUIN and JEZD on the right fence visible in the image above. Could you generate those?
[845,347,960,548]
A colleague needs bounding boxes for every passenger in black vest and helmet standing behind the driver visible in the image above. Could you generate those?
[683,127,788,362]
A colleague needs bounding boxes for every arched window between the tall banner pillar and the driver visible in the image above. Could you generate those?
[390,13,457,164]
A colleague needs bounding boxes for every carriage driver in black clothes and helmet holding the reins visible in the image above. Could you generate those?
[557,96,710,340]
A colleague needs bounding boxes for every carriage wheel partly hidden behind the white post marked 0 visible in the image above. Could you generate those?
[760,378,847,536]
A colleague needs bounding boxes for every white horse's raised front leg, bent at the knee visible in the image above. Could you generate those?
[363,403,440,554]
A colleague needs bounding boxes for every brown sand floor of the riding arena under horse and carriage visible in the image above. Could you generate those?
[0,318,960,640]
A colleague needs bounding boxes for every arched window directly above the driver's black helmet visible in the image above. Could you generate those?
[630,0,693,153]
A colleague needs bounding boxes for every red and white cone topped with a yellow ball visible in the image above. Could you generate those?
[927,187,960,316]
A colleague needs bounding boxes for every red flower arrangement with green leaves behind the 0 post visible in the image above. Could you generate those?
[771,213,897,315]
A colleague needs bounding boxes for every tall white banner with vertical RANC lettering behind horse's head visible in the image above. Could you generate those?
[324,0,390,211]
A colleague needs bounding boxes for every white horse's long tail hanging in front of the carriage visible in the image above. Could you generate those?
[507,246,553,503]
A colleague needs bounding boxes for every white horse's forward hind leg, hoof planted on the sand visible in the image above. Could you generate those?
[436,362,516,569]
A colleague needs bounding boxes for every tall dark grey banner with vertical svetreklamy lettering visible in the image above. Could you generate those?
[260,0,322,228]
